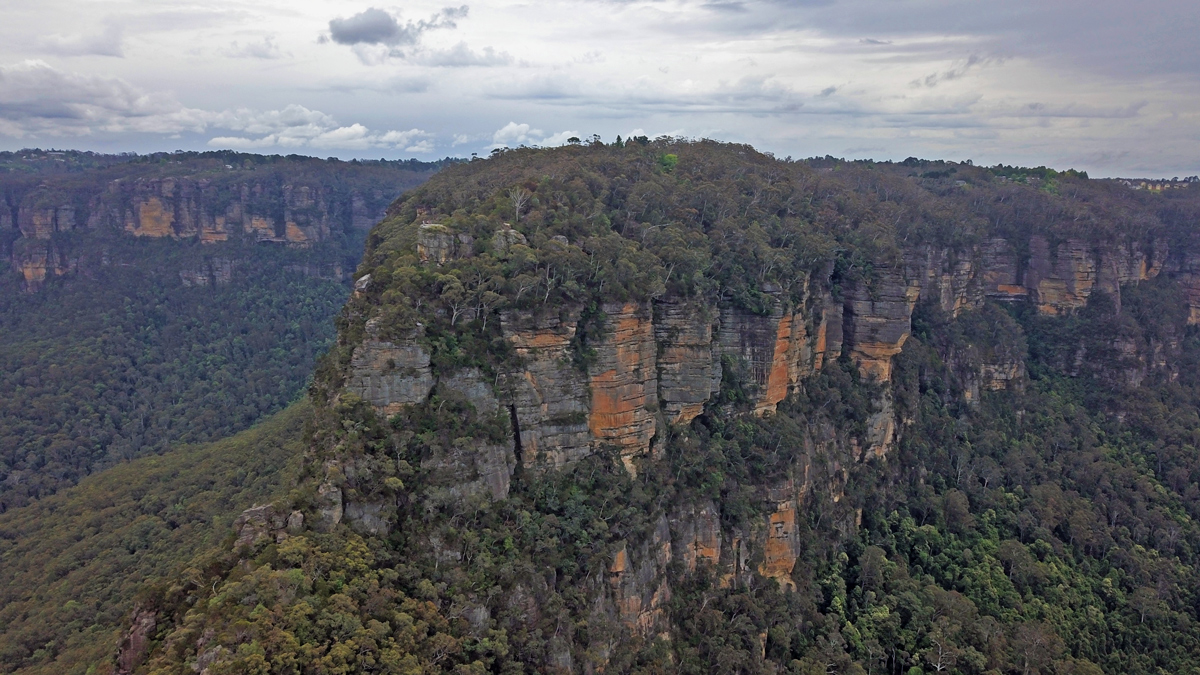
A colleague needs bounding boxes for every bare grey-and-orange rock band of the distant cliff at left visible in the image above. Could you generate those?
[0,168,398,291]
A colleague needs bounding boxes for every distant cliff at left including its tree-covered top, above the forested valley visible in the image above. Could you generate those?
[0,151,448,289]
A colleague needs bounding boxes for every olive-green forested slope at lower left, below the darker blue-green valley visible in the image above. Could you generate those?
[0,402,310,675]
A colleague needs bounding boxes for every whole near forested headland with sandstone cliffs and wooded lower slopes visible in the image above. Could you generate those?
[11,138,1200,675]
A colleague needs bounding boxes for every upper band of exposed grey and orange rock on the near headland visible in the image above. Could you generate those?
[348,222,1200,492]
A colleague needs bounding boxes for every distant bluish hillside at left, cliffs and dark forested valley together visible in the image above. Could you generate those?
[0,150,442,512]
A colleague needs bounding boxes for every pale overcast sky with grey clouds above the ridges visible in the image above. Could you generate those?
[0,0,1200,178]
